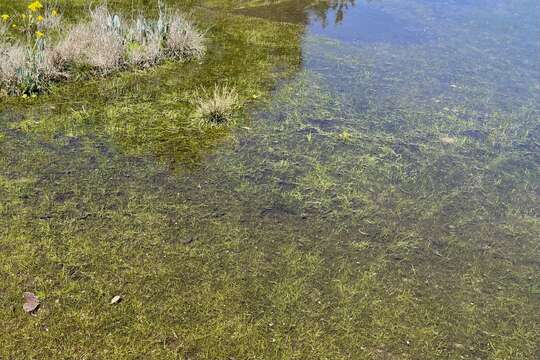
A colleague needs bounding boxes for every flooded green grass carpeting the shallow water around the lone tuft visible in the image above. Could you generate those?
[0,0,540,359]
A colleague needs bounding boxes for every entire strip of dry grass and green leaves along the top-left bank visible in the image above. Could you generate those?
[0,5,205,95]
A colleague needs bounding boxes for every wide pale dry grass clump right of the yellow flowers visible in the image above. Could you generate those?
[52,5,205,73]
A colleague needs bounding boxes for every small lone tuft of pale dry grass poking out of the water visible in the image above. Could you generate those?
[195,85,240,125]
